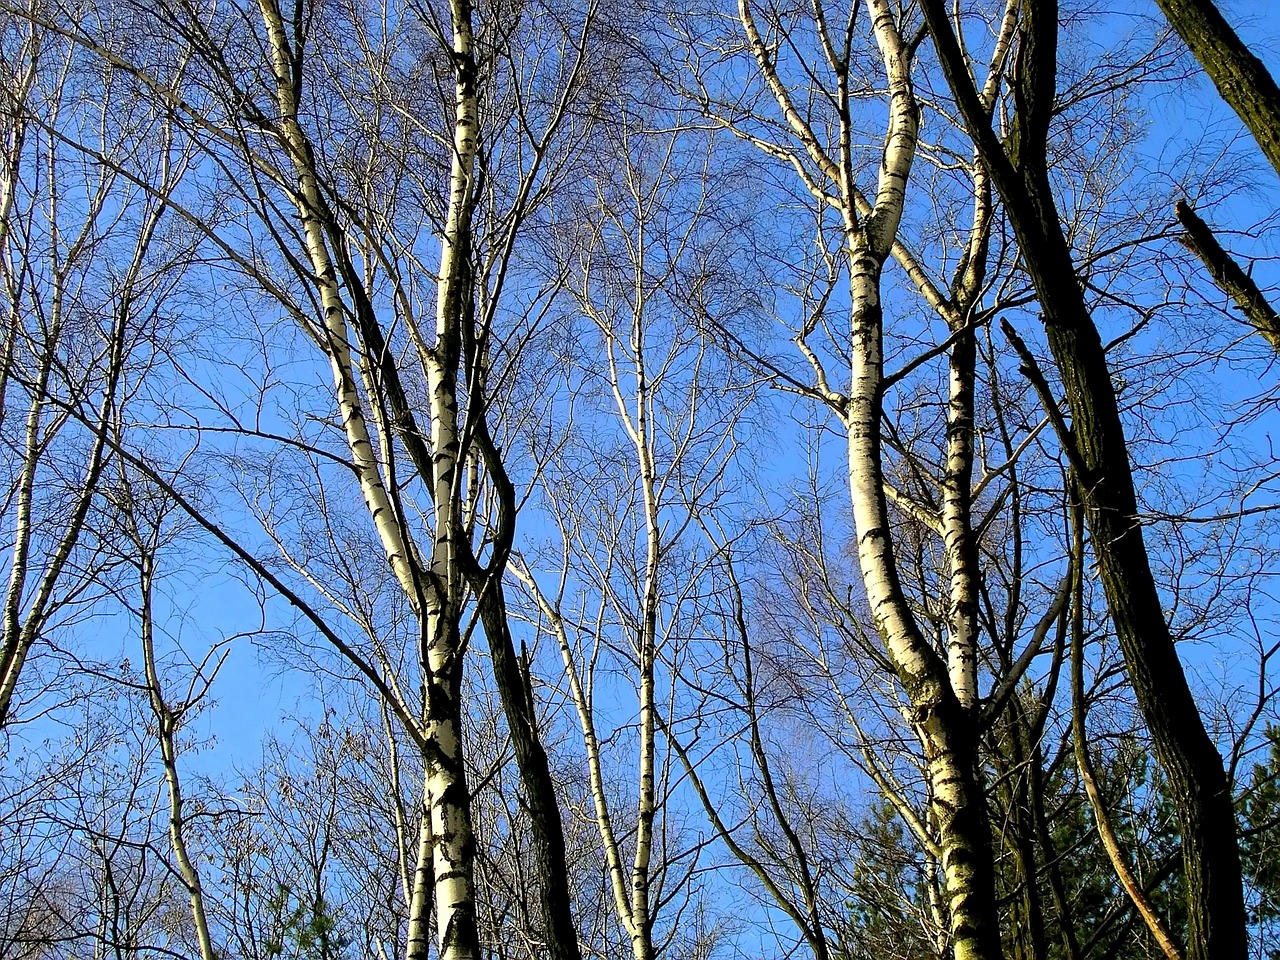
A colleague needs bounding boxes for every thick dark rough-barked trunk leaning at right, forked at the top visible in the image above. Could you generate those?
[922,0,1248,960]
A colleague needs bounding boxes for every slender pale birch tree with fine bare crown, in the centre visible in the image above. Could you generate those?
[513,118,751,960]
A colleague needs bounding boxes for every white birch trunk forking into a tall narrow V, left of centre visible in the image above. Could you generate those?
[259,0,479,960]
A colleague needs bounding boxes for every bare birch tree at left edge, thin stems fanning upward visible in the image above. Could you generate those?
[0,1,187,727]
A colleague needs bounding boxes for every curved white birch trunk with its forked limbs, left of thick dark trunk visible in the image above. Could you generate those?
[739,0,1009,960]
